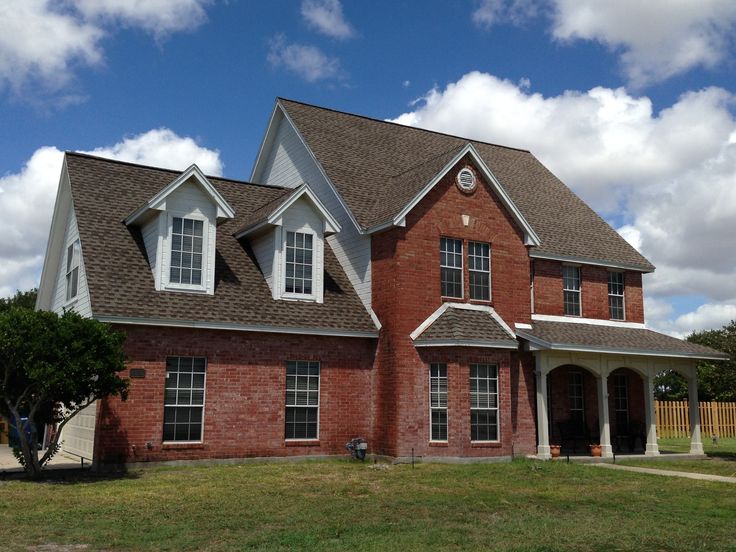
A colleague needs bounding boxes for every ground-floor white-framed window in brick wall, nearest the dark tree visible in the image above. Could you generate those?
[164,357,207,441]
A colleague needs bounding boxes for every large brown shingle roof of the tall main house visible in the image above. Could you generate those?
[279,99,654,271]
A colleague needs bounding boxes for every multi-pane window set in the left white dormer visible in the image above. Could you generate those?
[169,217,204,286]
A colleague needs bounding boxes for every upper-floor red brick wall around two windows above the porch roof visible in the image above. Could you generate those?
[534,259,644,323]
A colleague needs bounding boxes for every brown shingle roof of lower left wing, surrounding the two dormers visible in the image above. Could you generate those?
[66,153,376,333]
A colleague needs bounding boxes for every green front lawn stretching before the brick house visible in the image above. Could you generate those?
[0,461,736,551]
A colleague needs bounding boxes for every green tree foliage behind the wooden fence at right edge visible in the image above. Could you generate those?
[687,321,736,402]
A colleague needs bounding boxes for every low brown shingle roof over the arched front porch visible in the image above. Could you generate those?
[516,321,728,359]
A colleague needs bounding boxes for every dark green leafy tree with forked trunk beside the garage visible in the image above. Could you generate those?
[0,307,128,478]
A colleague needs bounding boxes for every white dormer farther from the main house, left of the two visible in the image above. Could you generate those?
[123,165,235,295]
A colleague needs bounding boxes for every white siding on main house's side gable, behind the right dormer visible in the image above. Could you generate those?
[257,116,371,308]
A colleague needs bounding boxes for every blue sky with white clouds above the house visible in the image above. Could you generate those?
[0,0,736,335]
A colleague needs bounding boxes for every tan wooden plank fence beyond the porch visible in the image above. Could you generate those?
[654,401,736,439]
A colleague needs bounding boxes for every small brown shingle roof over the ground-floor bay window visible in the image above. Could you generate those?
[414,305,518,348]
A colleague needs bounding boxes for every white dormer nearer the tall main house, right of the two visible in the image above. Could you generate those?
[234,184,340,303]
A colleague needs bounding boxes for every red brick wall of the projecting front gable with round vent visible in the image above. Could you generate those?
[372,155,536,456]
